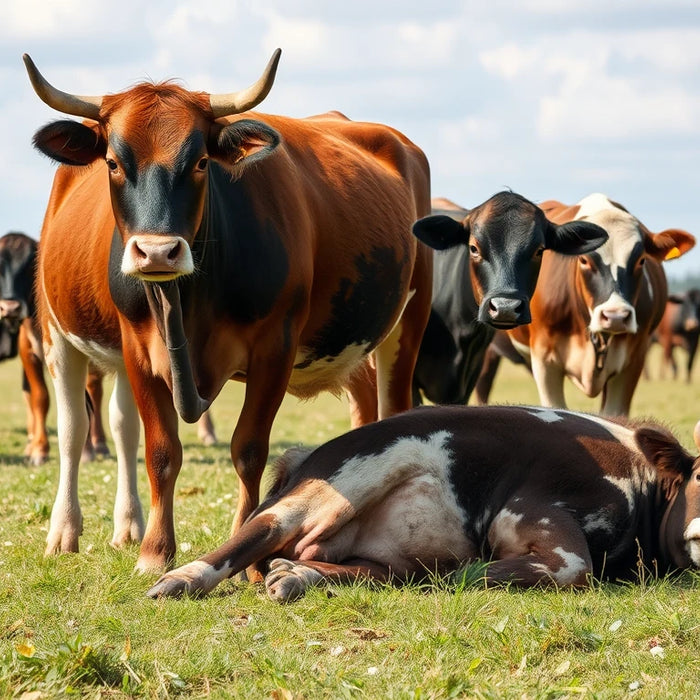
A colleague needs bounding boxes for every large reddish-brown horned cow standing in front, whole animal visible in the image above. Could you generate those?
[25,51,432,570]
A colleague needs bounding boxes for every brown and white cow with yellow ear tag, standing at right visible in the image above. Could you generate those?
[508,194,695,415]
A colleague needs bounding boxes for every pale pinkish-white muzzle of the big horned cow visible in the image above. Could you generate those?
[122,234,194,282]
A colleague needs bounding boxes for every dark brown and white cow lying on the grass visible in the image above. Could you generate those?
[148,406,700,601]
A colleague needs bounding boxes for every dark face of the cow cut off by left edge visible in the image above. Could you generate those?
[0,233,37,334]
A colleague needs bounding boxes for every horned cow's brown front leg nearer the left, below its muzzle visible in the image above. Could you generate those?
[127,372,182,572]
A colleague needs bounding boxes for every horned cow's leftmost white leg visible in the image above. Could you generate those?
[46,326,88,555]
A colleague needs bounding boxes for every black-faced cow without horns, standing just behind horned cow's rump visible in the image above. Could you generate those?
[413,192,607,404]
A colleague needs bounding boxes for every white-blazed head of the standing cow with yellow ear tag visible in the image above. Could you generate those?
[577,195,694,334]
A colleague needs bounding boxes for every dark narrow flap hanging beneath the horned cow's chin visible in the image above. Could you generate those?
[144,282,211,423]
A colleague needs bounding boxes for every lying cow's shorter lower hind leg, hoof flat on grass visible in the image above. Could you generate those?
[265,559,391,603]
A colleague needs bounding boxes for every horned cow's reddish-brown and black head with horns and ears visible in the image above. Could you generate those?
[25,53,279,282]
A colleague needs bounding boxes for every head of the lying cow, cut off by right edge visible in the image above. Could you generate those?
[635,422,700,568]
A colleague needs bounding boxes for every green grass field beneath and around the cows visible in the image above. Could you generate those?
[0,353,700,700]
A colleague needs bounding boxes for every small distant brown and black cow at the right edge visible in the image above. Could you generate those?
[652,289,700,382]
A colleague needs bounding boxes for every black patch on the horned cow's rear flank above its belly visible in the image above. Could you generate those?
[295,246,408,369]
